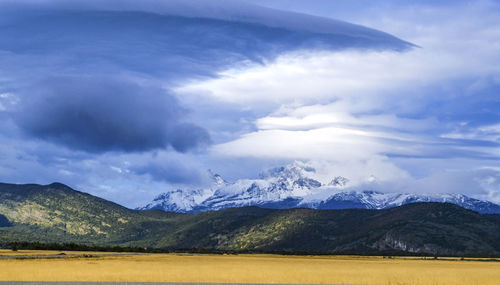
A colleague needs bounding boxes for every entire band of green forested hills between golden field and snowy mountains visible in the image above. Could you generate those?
[0,183,500,255]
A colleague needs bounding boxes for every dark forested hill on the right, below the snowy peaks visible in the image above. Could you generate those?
[181,203,500,254]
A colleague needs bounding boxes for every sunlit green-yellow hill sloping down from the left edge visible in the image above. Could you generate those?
[0,183,185,243]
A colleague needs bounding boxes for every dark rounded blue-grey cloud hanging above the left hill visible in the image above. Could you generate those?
[12,76,210,152]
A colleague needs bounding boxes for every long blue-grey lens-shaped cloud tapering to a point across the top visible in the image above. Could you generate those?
[0,1,409,78]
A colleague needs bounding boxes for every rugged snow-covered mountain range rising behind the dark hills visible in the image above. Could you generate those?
[140,162,500,213]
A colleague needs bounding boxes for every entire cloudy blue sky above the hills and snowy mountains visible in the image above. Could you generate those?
[0,0,500,207]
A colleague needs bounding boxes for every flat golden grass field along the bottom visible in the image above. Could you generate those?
[0,251,500,285]
